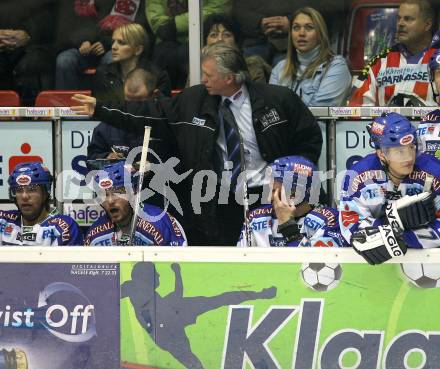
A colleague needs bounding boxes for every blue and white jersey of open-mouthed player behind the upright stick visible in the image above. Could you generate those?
[85,204,187,246]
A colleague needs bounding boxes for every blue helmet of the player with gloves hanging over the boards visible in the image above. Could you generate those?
[367,113,417,149]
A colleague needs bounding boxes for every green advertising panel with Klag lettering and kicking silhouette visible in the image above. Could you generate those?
[120,262,440,369]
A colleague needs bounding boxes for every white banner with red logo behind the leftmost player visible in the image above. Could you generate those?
[0,121,53,200]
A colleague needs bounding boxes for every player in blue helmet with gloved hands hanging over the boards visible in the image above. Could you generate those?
[339,113,440,264]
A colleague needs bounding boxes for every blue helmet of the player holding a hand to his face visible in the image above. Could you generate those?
[270,155,318,201]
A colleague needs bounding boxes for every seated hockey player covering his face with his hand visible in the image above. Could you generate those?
[238,156,348,247]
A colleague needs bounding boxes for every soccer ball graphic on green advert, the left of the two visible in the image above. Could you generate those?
[301,263,342,291]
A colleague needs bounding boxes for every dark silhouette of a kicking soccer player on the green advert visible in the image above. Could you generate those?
[121,262,276,369]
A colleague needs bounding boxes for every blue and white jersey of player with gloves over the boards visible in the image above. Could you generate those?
[339,154,440,248]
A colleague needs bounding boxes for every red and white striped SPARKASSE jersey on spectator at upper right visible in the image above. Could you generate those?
[349,44,437,106]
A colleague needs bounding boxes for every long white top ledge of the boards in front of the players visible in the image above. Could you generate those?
[0,246,440,262]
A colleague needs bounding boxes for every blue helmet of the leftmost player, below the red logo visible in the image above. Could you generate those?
[8,162,53,197]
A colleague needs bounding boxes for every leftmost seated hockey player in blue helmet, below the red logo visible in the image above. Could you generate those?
[0,162,83,246]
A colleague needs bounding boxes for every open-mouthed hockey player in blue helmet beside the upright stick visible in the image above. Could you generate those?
[85,162,187,246]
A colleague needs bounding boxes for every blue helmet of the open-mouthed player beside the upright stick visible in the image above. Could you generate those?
[95,161,138,190]
